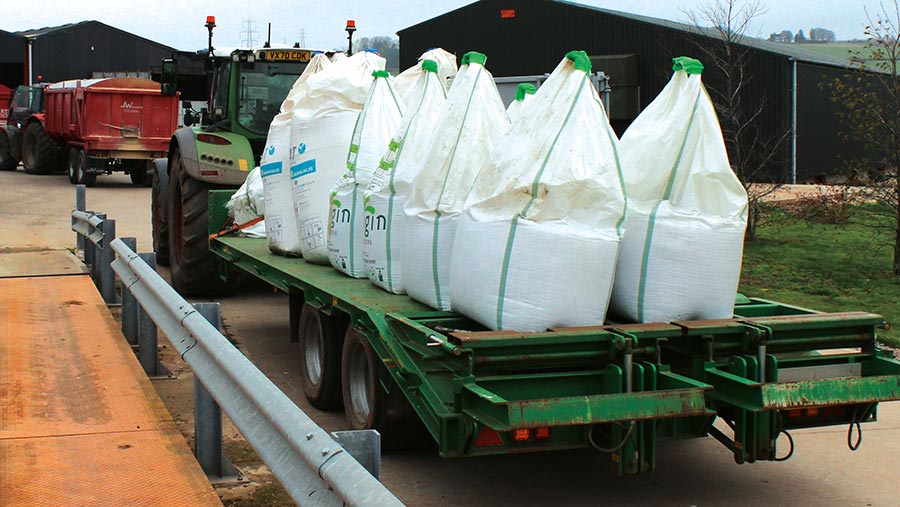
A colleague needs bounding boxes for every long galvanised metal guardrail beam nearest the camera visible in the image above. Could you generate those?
[110,239,403,506]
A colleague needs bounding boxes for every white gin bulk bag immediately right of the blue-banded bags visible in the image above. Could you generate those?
[328,70,403,278]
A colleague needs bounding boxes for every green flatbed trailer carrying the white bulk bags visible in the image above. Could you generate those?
[204,191,900,474]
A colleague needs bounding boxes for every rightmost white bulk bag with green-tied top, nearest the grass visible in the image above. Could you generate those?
[611,57,747,322]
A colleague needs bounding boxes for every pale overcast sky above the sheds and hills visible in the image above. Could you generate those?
[0,0,892,50]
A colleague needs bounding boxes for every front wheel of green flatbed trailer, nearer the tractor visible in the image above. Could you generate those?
[299,304,346,410]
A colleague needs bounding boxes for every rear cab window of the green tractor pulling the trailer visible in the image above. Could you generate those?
[238,62,306,134]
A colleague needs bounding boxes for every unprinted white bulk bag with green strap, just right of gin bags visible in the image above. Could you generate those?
[401,52,509,310]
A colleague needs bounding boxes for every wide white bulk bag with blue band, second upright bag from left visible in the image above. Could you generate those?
[290,52,385,264]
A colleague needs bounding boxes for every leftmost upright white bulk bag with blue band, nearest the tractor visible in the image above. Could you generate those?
[260,53,331,255]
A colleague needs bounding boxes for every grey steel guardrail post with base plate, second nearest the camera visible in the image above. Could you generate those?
[194,303,243,482]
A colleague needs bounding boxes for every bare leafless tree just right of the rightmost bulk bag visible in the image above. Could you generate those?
[685,0,790,241]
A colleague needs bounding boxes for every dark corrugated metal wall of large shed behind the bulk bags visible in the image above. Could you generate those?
[399,0,856,180]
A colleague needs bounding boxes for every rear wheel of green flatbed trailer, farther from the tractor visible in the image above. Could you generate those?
[341,326,428,450]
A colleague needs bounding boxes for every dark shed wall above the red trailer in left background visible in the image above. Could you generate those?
[32,23,172,82]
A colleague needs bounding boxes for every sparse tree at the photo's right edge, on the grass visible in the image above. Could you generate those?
[829,0,900,276]
